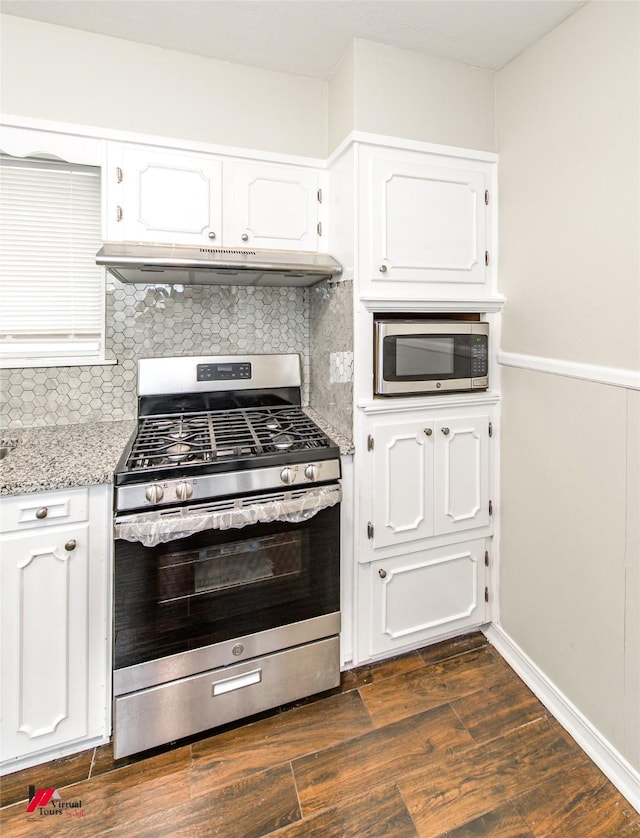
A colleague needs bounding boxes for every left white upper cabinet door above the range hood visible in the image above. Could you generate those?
[112,146,222,245]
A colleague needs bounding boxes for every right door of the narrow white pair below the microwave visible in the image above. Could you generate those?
[434,414,490,535]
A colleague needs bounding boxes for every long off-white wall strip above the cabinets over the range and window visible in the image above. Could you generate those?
[0,15,328,157]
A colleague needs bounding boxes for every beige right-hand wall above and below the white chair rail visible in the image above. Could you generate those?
[496,2,640,769]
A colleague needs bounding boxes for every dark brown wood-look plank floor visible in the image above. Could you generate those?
[0,633,640,838]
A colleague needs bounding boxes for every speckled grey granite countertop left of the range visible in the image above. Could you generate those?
[0,421,136,495]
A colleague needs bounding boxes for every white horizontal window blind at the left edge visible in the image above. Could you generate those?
[0,156,104,363]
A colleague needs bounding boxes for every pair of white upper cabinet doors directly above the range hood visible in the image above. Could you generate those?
[107,143,321,251]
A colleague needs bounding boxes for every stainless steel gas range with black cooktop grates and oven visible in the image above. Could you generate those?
[114,355,341,758]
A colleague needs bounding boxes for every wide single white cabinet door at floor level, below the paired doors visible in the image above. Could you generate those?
[367,539,487,656]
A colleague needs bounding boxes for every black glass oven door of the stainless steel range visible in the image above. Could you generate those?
[114,496,340,688]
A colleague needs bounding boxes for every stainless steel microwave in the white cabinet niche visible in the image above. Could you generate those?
[374,319,489,396]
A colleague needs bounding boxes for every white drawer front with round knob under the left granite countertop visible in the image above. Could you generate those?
[0,488,89,532]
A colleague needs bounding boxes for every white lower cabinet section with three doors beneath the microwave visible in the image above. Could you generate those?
[354,396,496,663]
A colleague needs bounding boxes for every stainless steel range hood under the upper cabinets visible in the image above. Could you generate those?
[96,242,342,287]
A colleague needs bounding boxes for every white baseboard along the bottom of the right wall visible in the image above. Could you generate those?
[483,623,640,812]
